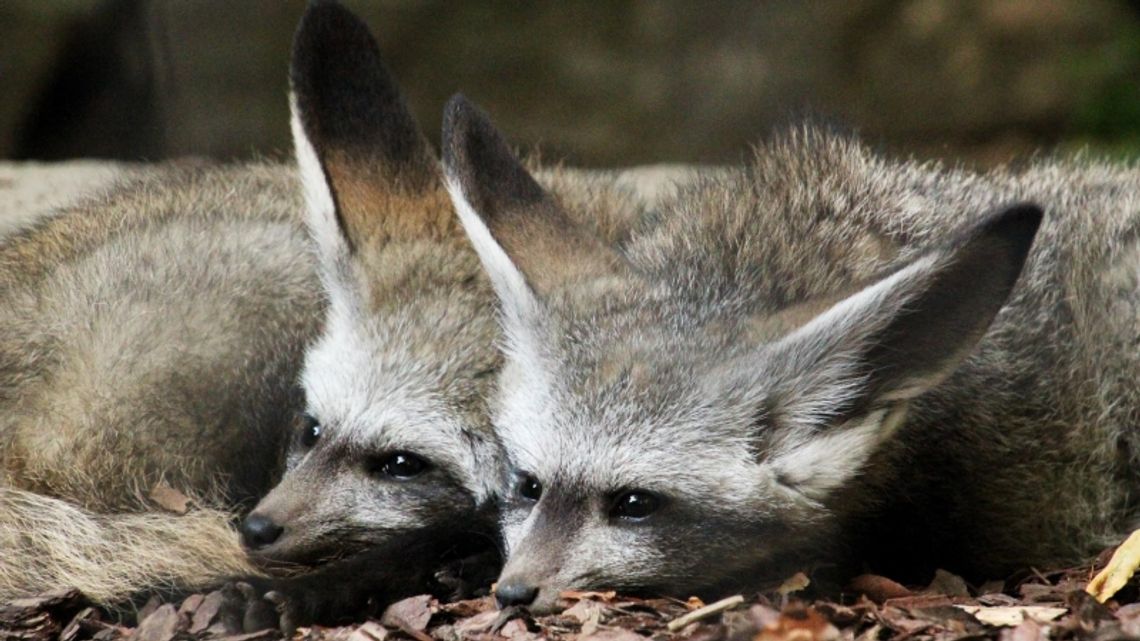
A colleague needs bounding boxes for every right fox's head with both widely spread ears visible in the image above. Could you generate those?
[443,97,1041,611]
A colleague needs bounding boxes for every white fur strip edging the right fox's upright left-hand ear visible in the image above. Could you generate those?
[447,178,538,321]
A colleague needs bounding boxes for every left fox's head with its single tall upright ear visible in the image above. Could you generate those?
[242,2,499,574]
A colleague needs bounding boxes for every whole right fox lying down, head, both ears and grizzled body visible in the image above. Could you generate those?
[445,98,1140,610]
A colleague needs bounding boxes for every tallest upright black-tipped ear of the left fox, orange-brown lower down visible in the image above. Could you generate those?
[290,0,442,270]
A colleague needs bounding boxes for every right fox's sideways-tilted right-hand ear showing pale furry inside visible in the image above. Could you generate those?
[765,204,1042,497]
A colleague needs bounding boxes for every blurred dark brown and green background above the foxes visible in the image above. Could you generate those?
[0,0,1140,165]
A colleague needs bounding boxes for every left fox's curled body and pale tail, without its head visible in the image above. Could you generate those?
[0,159,324,600]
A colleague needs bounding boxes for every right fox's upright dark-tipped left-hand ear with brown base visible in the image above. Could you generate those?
[442,96,618,305]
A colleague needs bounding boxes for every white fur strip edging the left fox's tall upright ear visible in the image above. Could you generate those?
[288,91,349,266]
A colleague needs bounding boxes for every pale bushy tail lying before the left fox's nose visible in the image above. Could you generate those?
[0,487,259,605]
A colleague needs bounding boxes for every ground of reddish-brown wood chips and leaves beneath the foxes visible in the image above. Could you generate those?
[0,538,1140,641]
